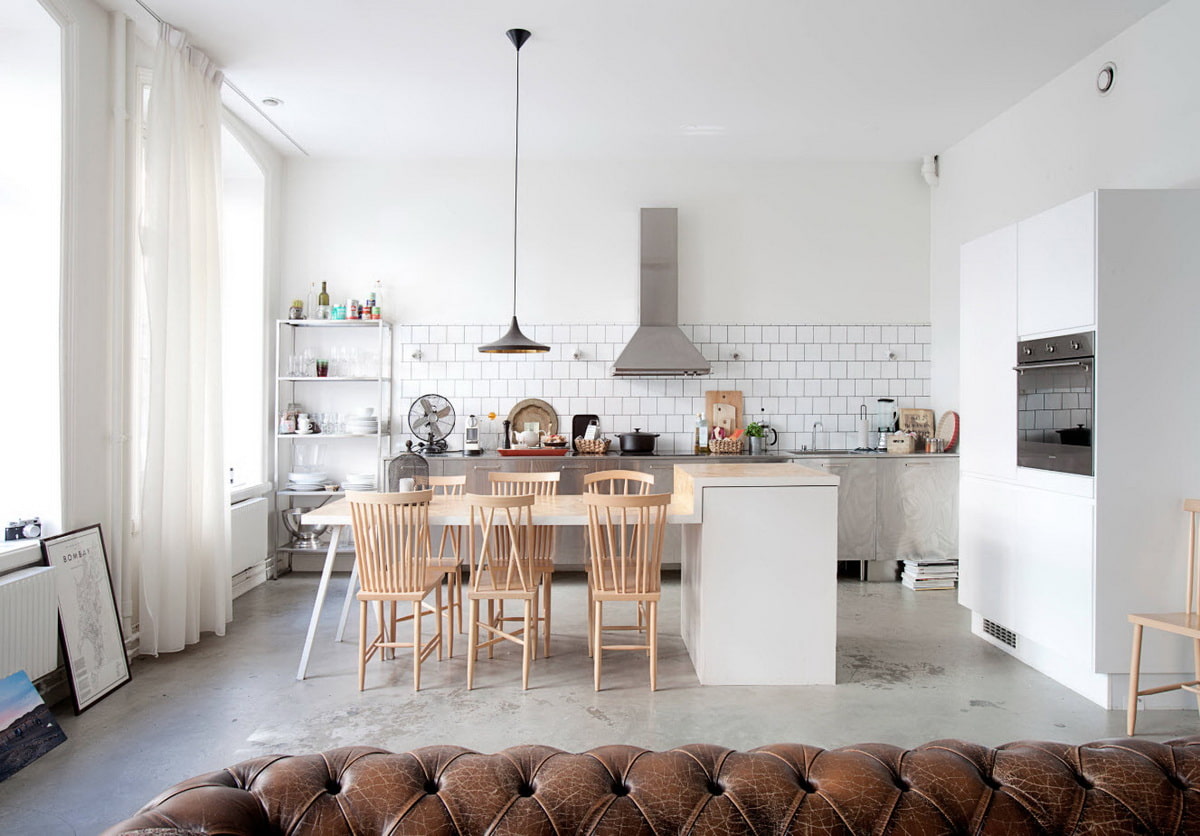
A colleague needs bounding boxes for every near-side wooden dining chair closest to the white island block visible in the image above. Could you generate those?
[583,493,671,691]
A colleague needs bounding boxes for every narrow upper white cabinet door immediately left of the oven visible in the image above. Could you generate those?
[959,225,1016,479]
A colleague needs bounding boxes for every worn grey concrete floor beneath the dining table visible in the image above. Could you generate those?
[0,575,1200,836]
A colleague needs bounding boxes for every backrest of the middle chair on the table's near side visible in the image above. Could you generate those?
[466,493,538,591]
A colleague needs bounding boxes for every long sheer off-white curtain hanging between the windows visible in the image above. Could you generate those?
[131,25,233,654]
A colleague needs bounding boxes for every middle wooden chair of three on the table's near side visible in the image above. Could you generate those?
[466,493,541,691]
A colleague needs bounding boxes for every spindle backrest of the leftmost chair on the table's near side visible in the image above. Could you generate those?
[346,491,433,594]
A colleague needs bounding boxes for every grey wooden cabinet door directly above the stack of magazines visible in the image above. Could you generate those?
[875,457,959,560]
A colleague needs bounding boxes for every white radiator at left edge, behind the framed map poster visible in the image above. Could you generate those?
[0,566,59,679]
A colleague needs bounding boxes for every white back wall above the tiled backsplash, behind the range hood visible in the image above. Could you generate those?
[278,160,929,325]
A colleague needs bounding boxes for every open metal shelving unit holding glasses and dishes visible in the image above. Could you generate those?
[268,319,392,578]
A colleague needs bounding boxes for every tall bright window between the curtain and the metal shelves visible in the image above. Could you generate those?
[221,128,268,487]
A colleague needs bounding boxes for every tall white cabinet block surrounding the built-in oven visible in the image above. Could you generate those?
[959,190,1200,708]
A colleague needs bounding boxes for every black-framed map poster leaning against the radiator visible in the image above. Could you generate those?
[42,524,130,714]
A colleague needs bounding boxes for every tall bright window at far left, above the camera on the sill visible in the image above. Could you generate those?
[0,2,62,531]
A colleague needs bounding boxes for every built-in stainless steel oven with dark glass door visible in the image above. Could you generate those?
[1014,331,1096,476]
